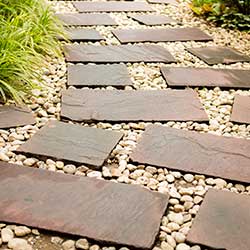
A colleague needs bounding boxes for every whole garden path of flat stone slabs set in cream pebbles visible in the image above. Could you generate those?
[0,0,250,250]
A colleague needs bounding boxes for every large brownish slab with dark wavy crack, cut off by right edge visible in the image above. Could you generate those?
[131,125,250,183]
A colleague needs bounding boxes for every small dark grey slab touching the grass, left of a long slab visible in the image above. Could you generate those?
[63,28,104,42]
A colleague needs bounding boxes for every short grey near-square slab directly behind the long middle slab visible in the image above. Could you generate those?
[68,64,133,87]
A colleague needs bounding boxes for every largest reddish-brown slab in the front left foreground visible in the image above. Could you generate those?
[0,161,168,249]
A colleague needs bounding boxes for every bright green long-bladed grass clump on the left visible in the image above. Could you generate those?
[0,0,64,103]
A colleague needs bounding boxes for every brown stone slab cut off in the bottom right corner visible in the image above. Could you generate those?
[187,189,250,250]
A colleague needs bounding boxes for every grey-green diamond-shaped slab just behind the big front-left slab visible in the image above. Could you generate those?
[17,121,123,167]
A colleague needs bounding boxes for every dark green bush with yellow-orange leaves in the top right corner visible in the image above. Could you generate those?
[190,0,250,31]
